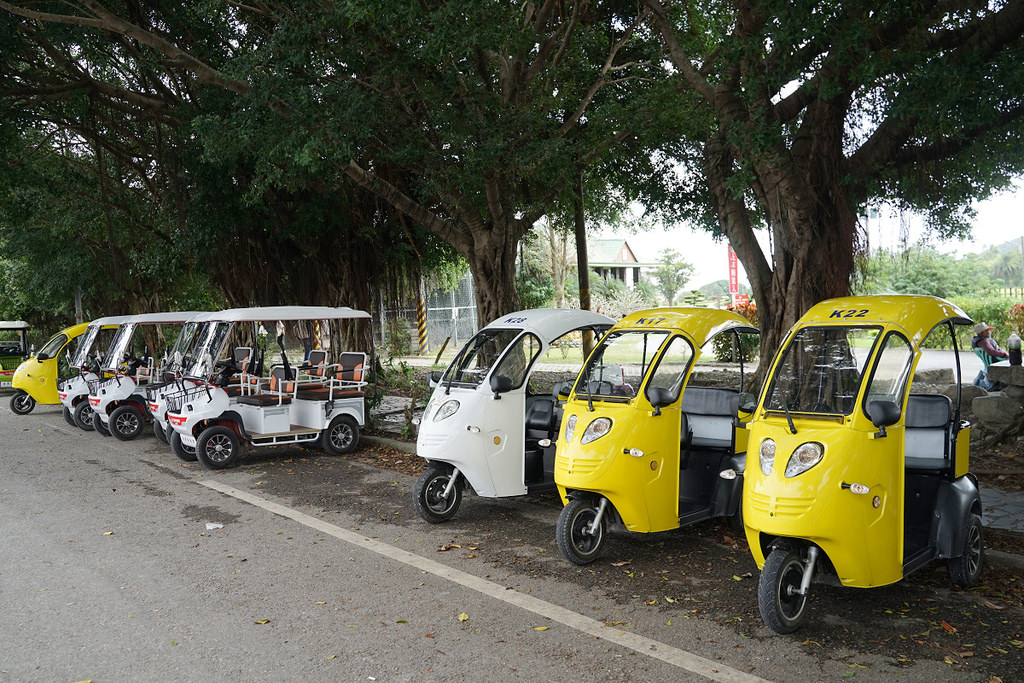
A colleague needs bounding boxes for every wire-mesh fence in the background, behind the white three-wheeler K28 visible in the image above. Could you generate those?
[375,274,477,356]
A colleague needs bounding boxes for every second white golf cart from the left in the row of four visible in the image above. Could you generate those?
[89,310,202,441]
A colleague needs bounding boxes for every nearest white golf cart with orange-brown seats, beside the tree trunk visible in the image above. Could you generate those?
[166,306,370,469]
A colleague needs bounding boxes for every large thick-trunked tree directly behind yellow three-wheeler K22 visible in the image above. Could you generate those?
[642,0,1024,358]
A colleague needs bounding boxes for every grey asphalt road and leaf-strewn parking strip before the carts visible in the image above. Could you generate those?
[0,401,1024,683]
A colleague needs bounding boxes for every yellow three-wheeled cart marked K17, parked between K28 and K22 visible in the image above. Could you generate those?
[555,308,758,564]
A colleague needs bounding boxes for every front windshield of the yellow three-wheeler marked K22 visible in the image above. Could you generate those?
[765,327,882,415]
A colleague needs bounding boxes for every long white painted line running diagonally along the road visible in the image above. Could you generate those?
[199,479,765,683]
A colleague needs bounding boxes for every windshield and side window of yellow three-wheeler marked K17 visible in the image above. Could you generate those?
[575,330,679,399]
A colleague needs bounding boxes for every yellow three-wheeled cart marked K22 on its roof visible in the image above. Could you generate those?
[743,296,982,633]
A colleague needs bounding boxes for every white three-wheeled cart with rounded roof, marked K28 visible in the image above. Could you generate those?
[415,308,614,523]
